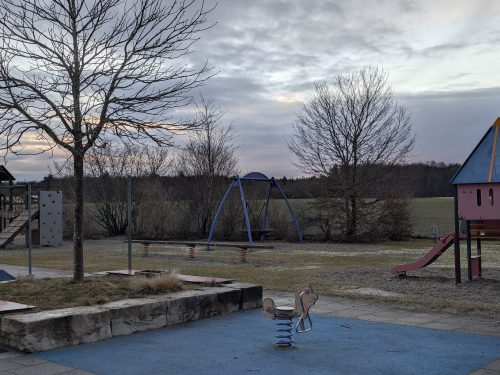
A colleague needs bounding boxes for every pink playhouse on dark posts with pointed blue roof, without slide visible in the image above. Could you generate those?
[450,118,500,283]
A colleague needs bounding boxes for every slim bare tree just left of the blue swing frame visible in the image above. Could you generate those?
[178,98,237,236]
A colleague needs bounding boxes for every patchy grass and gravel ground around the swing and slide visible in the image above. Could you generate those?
[0,238,500,317]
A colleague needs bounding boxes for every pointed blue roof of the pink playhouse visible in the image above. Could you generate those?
[450,117,500,185]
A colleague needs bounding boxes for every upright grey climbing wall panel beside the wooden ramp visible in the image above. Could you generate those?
[39,190,62,246]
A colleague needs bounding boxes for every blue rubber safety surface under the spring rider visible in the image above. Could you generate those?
[36,311,500,375]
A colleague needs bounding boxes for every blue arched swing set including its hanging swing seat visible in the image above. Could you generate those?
[207,172,302,247]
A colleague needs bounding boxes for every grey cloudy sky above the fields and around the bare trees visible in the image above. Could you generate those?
[7,0,500,179]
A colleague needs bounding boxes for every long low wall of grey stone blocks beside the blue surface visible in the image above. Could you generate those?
[0,283,262,352]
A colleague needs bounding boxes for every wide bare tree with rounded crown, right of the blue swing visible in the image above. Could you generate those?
[289,67,415,240]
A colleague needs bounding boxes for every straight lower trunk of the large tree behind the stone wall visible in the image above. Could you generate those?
[73,154,84,281]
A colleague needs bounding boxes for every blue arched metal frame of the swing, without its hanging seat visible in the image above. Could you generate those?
[207,172,302,247]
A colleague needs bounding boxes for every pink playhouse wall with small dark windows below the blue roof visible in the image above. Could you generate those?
[457,184,500,220]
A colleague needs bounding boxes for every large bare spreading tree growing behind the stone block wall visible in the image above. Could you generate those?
[0,0,210,280]
